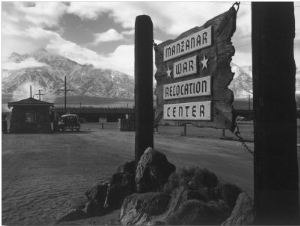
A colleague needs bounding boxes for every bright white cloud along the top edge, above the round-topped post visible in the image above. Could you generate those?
[67,2,237,35]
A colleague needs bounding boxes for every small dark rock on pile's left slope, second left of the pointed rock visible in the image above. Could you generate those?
[85,181,109,217]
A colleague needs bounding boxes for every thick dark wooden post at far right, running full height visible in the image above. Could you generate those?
[252,2,299,225]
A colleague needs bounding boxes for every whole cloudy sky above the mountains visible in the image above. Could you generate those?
[1,1,300,76]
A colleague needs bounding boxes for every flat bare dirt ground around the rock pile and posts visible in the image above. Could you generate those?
[2,123,300,225]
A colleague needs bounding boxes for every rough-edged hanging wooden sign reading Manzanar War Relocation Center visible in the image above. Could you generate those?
[154,7,236,130]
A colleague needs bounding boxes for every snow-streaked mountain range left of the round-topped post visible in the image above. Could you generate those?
[2,49,134,99]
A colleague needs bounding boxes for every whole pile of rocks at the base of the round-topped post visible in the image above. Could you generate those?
[56,148,253,225]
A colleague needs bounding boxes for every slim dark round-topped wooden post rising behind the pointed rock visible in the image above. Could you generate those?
[134,15,154,165]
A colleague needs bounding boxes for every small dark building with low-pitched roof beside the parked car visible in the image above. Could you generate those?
[8,97,53,133]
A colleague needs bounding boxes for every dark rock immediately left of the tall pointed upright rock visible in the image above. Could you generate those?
[104,172,135,209]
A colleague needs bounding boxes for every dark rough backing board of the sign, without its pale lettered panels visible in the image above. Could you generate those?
[154,7,236,131]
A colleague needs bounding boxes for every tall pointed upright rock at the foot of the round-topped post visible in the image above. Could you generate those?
[135,148,176,193]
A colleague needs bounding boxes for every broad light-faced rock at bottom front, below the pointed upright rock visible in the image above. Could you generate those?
[120,192,170,225]
